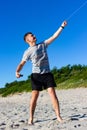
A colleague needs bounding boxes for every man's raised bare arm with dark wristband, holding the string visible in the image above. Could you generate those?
[45,21,67,45]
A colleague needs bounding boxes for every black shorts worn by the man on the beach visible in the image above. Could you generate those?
[31,73,56,91]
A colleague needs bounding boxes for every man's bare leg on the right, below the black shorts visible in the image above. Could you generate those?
[48,87,63,122]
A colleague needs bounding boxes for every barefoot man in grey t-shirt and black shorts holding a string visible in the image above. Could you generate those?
[16,21,67,124]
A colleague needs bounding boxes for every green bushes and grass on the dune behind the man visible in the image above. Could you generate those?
[0,64,87,96]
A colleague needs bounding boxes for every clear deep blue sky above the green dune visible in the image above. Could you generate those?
[0,0,87,87]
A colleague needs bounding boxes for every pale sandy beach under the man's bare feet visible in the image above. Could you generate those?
[0,88,87,130]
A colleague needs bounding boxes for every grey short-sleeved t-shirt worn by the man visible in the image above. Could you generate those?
[22,42,50,74]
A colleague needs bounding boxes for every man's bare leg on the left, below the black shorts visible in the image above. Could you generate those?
[28,90,39,124]
